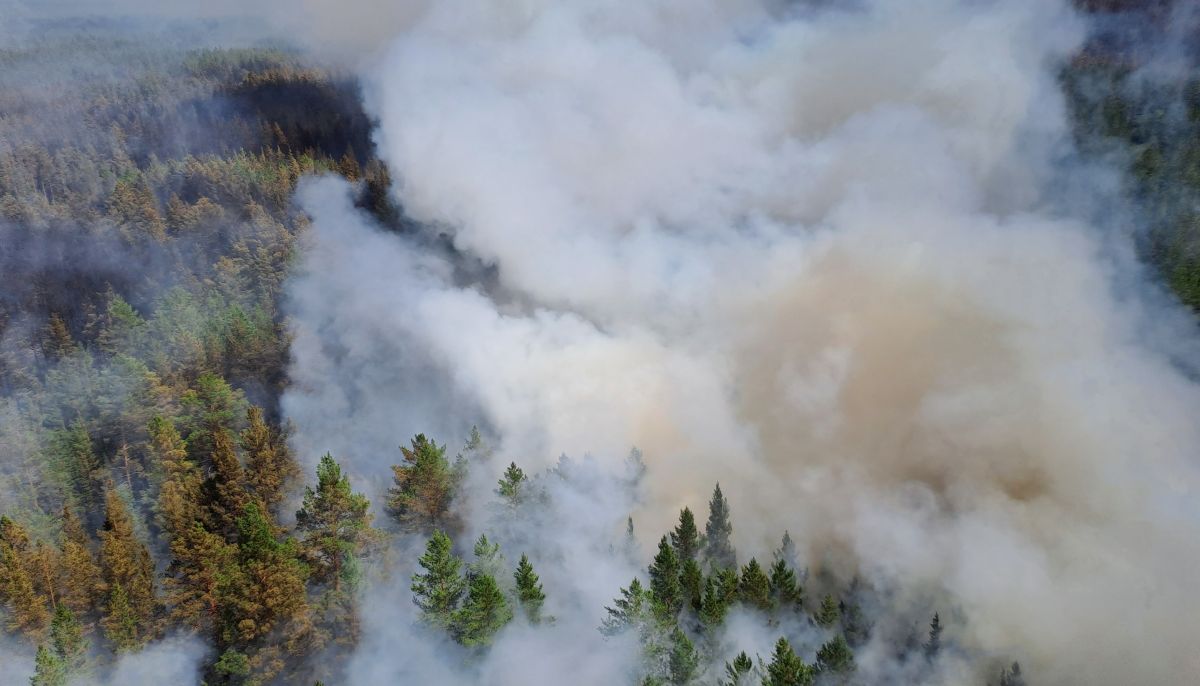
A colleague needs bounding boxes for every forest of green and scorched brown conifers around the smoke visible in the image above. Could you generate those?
[0,1,1200,686]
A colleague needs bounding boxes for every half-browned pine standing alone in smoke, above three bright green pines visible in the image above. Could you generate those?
[388,434,456,531]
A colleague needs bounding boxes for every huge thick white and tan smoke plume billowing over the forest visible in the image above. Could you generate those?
[284,0,1200,685]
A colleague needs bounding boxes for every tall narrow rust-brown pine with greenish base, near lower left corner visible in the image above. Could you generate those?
[100,487,157,649]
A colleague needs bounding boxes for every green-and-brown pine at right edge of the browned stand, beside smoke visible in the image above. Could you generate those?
[296,453,376,591]
